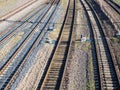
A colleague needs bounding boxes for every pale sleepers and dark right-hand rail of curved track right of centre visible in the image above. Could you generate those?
[81,1,119,90]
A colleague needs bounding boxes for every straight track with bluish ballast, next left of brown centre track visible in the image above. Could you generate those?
[0,1,59,90]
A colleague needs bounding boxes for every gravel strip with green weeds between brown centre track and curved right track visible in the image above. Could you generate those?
[69,0,94,90]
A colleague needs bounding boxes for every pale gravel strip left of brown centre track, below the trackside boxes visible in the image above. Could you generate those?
[11,2,63,90]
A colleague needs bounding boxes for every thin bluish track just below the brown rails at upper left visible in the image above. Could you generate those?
[0,4,46,44]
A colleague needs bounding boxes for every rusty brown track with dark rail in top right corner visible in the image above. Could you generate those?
[101,0,120,35]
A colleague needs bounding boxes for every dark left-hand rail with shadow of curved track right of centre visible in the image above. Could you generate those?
[80,0,101,90]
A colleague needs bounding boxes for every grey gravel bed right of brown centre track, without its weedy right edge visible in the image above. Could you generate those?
[63,0,89,90]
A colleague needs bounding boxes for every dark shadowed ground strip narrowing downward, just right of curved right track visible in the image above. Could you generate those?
[88,1,120,86]
